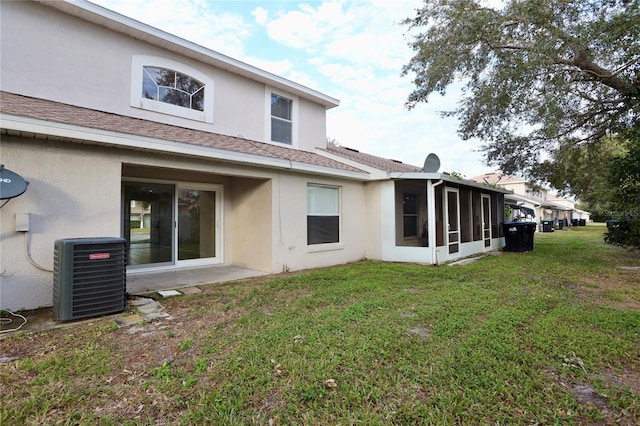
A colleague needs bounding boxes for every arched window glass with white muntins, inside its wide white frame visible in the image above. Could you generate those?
[142,66,205,111]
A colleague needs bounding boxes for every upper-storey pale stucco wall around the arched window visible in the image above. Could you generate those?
[0,1,326,151]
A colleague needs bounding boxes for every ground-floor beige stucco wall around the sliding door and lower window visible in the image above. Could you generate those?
[0,135,370,310]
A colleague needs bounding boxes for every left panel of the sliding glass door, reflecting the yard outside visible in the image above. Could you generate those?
[123,182,174,266]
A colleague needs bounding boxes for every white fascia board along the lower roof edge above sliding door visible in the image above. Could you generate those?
[0,114,369,180]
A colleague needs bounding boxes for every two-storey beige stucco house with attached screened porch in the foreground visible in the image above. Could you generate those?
[0,1,510,309]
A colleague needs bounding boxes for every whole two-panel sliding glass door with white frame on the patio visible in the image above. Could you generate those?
[122,182,222,269]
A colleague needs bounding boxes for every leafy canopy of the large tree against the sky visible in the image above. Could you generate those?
[403,0,640,180]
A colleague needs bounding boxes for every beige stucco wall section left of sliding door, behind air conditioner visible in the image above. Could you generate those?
[0,135,120,309]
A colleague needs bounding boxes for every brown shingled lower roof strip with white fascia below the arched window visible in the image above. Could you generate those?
[0,92,367,178]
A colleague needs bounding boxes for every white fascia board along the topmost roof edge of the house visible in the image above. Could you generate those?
[36,0,340,109]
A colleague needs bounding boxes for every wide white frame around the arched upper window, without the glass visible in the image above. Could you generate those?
[130,55,213,123]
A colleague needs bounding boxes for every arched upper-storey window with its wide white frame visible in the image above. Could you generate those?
[131,55,213,123]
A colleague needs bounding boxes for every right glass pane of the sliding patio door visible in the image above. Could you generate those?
[178,189,216,260]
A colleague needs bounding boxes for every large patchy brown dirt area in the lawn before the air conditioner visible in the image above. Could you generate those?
[0,282,260,425]
